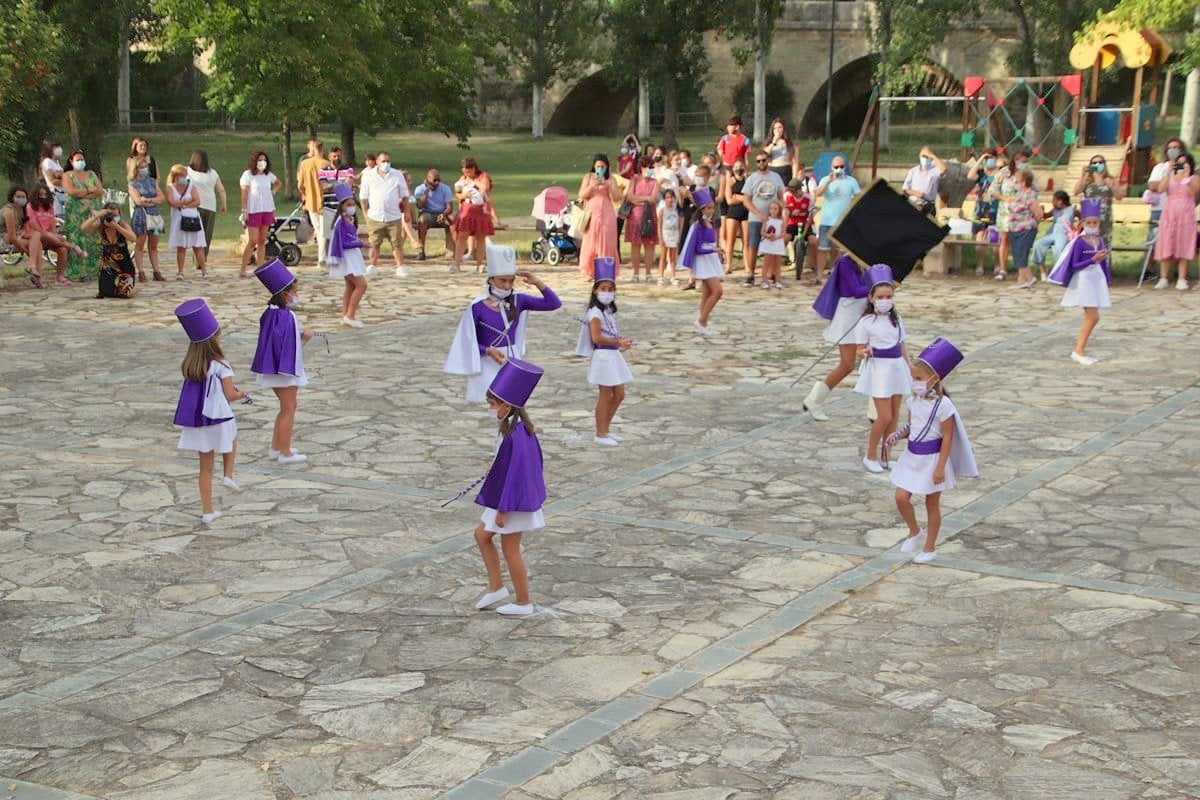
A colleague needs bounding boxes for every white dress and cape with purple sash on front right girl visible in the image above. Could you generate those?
[892,395,979,494]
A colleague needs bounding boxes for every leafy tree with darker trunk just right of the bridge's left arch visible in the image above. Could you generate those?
[606,0,714,146]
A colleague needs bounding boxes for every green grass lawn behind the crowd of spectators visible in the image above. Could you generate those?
[93,126,1161,275]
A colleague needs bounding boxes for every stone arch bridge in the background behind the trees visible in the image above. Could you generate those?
[511,0,1016,136]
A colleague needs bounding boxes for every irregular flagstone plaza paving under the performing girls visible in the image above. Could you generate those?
[0,261,1200,800]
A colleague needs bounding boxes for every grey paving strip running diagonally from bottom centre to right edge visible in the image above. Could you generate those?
[439,387,1200,800]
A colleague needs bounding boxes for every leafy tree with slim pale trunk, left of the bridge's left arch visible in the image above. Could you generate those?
[492,0,598,139]
